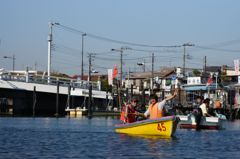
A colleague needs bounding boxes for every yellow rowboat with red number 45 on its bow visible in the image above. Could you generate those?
[115,116,179,137]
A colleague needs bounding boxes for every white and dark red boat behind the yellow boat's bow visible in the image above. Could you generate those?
[178,115,222,130]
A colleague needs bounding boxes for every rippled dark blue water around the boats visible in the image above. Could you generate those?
[0,117,240,159]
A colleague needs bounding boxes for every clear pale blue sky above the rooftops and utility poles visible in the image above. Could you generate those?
[0,0,240,75]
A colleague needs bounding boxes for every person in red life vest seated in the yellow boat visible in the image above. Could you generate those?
[120,98,138,124]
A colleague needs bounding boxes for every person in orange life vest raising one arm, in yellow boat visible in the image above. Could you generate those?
[144,90,177,119]
